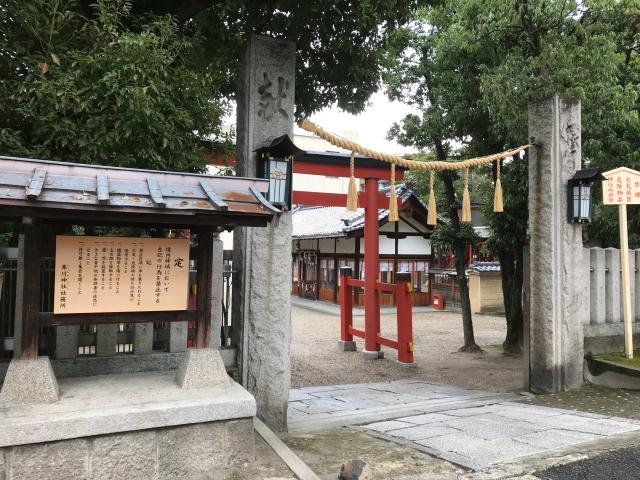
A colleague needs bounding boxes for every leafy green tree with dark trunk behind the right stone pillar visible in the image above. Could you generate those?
[387,0,640,351]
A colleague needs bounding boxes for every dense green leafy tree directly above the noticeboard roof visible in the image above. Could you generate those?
[0,0,230,171]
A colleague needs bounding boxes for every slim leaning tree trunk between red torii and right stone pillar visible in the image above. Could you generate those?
[442,171,482,352]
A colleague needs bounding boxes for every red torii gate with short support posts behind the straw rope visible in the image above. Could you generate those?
[291,153,415,366]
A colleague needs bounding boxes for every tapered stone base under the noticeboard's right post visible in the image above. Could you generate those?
[176,348,231,389]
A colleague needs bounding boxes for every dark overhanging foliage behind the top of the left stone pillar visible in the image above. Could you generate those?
[118,0,429,116]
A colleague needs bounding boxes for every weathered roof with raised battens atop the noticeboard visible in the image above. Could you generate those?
[0,156,280,228]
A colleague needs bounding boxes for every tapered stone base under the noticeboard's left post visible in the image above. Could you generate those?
[0,357,59,407]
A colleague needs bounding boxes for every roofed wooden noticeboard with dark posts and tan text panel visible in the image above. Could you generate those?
[0,156,281,359]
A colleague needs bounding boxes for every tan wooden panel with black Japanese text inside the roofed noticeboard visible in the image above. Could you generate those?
[53,235,189,314]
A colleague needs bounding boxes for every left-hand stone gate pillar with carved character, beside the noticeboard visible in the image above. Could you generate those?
[232,35,296,430]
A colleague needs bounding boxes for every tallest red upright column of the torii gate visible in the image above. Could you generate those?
[362,178,381,359]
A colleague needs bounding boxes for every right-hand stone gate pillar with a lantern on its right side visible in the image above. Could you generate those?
[529,95,587,393]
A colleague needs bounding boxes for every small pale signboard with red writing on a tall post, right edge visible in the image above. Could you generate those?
[602,167,640,358]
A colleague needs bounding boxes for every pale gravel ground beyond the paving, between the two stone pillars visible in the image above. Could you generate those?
[291,306,522,392]
